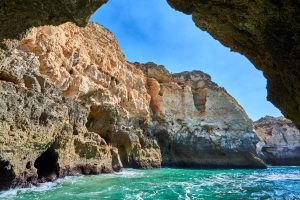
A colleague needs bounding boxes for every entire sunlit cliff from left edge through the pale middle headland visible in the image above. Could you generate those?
[0,23,265,189]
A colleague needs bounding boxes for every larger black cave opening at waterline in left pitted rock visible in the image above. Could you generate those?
[34,147,59,180]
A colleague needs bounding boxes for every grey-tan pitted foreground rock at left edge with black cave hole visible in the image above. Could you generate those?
[0,42,122,189]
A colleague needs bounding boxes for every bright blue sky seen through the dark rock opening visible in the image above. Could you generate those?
[91,0,281,120]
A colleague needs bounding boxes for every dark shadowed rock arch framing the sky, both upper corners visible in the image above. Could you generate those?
[0,0,300,128]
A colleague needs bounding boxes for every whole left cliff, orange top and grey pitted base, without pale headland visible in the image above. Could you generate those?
[0,23,161,188]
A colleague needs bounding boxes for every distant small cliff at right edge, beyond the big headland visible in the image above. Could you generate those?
[254,116,300,165]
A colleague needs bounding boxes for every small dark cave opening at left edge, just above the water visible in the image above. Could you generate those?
[0,160,16,190]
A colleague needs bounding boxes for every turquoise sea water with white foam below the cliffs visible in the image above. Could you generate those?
[0,167,300,200]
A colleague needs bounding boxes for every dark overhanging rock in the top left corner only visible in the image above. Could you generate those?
[0,0,108,40]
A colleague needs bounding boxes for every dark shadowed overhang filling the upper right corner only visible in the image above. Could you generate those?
[167,0,300,128]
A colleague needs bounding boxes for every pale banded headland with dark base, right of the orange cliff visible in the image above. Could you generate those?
[135,63,265,168]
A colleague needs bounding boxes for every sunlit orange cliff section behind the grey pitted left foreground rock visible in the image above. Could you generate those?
[20,23,161,168]
